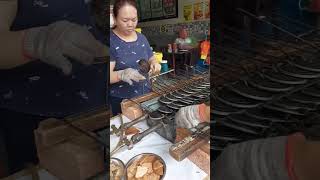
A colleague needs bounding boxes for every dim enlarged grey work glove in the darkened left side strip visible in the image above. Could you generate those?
[23,21,108,75]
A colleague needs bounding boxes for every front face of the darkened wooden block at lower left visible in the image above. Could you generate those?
[37,136,104,180]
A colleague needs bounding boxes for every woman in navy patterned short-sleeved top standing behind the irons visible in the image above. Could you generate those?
[110,0,161,115]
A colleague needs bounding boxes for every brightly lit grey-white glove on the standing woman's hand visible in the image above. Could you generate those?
[118,68,146,85]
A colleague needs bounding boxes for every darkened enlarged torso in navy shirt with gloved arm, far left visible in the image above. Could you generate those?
[0,0,108,176]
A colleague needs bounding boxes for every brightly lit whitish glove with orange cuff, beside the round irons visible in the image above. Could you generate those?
[175,105,201,129]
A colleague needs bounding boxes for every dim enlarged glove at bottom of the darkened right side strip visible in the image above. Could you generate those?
[213,136,289,180]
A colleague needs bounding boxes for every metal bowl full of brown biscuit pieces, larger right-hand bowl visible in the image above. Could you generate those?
[125,153,166,180]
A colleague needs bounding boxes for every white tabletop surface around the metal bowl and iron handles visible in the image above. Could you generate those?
[110,116,208,180]
